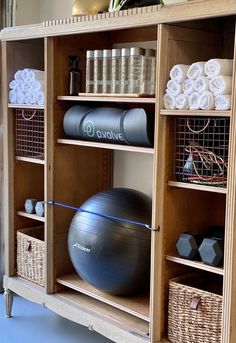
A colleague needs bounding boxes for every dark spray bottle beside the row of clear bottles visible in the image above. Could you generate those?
[69,56,82,95]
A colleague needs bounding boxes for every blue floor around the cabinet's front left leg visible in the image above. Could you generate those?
[0,294,111,343]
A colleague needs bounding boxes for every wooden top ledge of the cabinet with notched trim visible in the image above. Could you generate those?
[1,0,236,40]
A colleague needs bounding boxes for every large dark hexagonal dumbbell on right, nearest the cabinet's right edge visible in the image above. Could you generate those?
[199,237,224,267]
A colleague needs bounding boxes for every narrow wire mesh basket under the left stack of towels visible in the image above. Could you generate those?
[15,109,44,159]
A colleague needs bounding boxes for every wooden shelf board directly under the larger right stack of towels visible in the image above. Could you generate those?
[160,110,231,117]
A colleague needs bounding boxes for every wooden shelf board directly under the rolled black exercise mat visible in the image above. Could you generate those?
[57,139,154,154]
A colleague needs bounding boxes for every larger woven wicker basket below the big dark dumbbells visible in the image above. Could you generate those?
[168,273,222,343]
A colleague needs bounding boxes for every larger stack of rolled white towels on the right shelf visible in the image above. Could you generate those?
[164,58,233,110]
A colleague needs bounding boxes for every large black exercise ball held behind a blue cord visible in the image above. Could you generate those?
[68,188,151,295]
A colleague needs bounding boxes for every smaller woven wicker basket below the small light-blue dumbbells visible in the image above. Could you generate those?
[17,226,45,286]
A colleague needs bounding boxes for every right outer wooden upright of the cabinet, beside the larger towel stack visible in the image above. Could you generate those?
[222,20,236,343]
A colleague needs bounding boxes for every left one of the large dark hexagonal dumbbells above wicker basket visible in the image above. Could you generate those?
[176,232,202,260]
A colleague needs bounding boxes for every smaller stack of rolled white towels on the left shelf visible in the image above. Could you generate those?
[9,68,44,105]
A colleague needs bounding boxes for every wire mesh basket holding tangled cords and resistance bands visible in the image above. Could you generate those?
[175,117,229,187]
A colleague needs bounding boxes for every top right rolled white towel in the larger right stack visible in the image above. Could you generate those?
[205,58,233,78]
